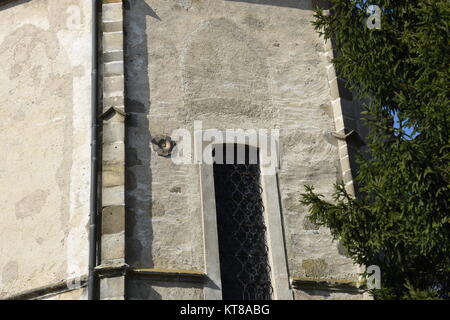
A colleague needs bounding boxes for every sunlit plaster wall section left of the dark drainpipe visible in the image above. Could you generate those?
[0,0,91,298]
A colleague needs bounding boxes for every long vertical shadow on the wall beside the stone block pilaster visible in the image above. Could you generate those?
[124,0,161,276]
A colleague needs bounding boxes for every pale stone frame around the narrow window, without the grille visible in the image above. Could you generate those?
[194,130,293,300]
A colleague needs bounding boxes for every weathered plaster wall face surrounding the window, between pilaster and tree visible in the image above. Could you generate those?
[124,0,366,299]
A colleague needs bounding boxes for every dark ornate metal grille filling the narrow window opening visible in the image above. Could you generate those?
[214,148,273,300]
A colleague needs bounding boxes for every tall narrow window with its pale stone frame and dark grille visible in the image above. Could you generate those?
[194,129,293,300]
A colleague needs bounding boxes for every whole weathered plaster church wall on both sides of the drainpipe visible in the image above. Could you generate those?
[0,0,370,300]
